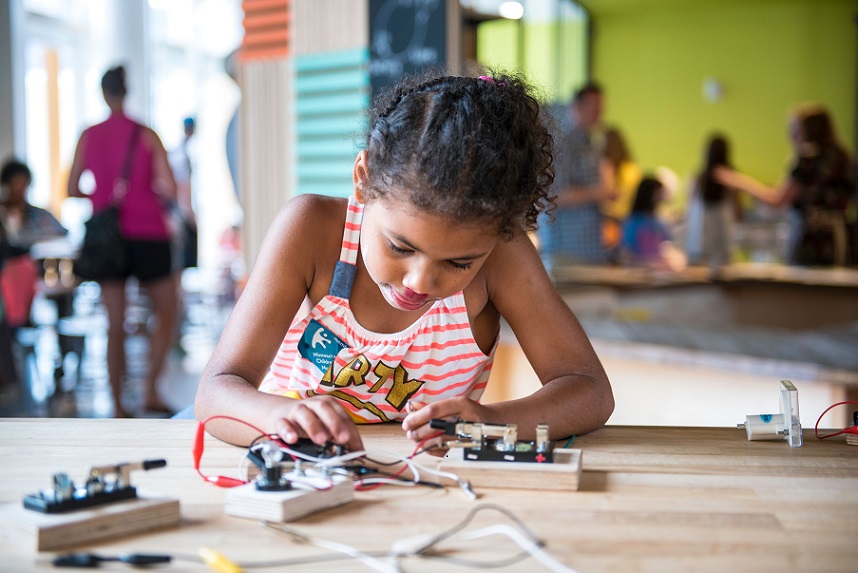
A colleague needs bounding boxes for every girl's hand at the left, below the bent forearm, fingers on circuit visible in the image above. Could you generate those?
[273,396,363,452]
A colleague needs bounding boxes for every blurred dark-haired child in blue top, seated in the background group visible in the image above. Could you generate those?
[623,177,670,268]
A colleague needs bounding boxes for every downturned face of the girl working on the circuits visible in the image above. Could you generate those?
[360,199,498,311]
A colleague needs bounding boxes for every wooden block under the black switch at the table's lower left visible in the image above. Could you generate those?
[0,497,180,551]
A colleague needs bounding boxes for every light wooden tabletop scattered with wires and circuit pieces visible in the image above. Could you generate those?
[0,419,858,573]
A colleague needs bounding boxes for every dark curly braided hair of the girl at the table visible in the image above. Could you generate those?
[363,70,554,239]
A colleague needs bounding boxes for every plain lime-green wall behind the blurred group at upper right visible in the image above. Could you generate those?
[582,0,858,187]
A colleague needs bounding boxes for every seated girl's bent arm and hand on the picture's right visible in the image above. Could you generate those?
[403,233,614,440]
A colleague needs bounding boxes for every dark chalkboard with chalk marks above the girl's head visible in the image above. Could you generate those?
[369,0,447,95]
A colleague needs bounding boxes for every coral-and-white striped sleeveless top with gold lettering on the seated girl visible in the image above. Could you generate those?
[259,197,497,423]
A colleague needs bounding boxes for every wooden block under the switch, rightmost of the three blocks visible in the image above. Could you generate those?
[438,448,582,491]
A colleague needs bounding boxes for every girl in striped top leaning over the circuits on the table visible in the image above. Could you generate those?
[195,72,614,449]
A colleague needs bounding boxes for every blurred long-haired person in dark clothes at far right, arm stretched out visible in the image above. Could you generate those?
[715,104,855,266]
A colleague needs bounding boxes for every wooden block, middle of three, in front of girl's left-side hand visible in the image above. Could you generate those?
[223,476,354,523]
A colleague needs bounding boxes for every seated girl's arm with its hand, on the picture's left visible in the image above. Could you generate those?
[194,196,361,450]
